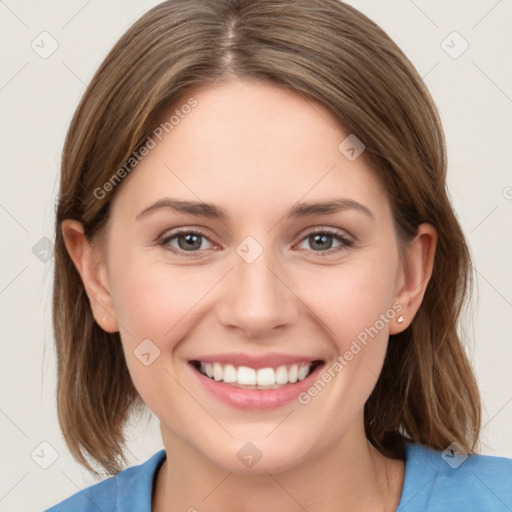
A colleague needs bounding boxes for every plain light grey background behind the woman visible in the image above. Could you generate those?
[0,0,512,512]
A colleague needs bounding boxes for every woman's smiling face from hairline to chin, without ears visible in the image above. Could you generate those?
[89,81,416,472]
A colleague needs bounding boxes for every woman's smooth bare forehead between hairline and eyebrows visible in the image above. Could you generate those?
[111,80,387,222]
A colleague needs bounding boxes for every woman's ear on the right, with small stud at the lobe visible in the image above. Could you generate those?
[389,224,437,334]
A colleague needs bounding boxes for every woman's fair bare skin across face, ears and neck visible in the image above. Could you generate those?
[63,80,436,512]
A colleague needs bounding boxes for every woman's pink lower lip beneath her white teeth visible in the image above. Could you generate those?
[191,364,323,409]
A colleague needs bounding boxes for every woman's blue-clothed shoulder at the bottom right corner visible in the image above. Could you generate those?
[397,443,512,512]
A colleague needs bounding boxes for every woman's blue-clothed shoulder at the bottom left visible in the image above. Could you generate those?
[45,450,165,512]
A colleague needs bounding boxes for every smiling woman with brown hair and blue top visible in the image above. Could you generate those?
[46,0,512,512]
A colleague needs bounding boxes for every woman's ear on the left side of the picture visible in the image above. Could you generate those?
[61,219,119,332]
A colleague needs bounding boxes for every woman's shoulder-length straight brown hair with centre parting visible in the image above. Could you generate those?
[53,0,481,474]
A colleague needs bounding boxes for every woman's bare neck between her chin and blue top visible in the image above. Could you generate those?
[152,420,405,512]
